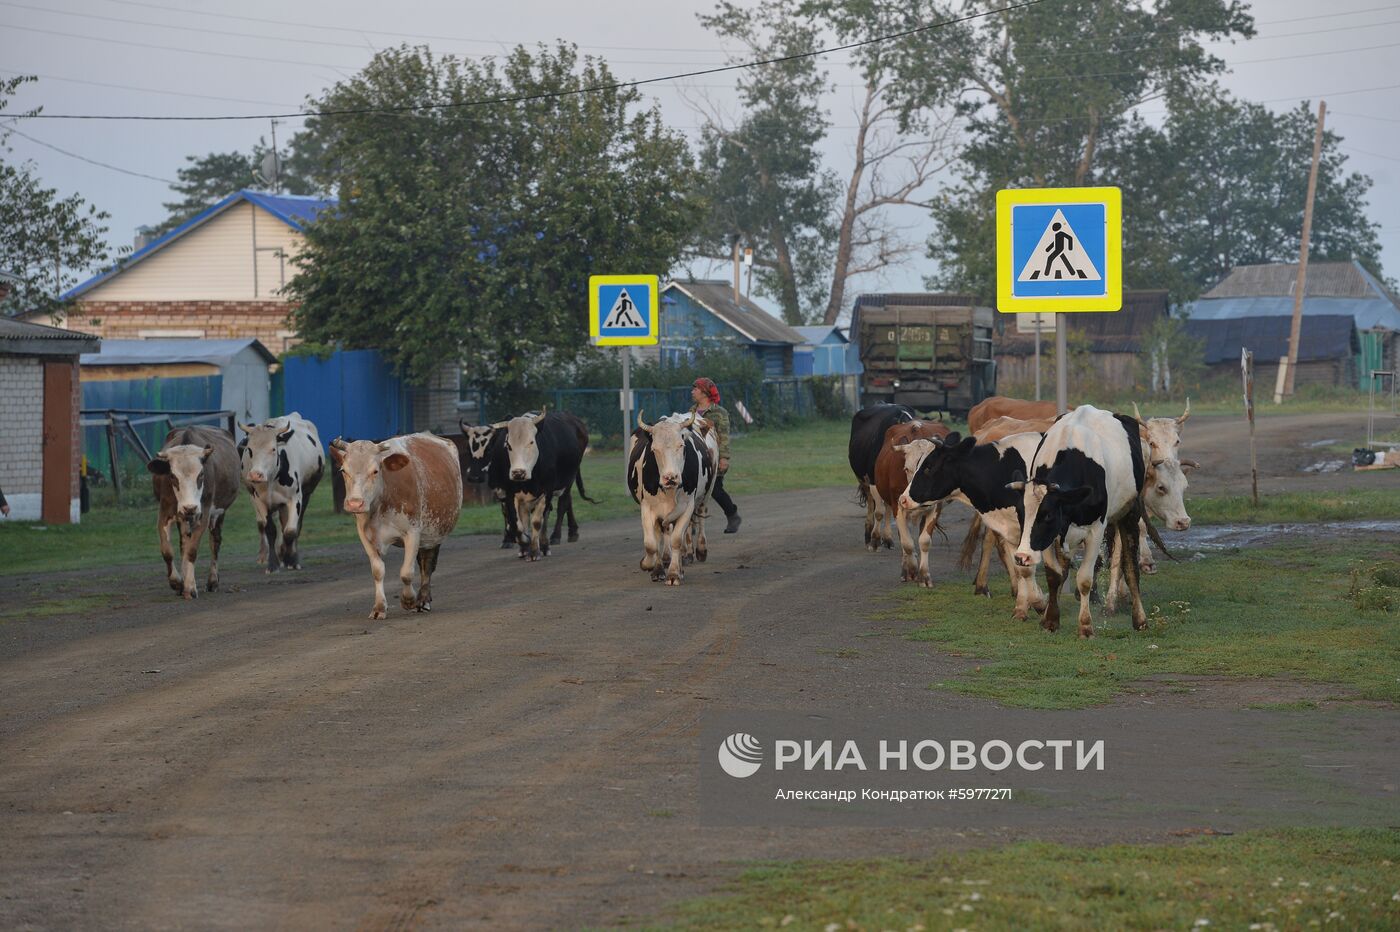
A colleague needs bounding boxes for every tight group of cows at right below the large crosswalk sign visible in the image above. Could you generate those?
[850,396,1197,637]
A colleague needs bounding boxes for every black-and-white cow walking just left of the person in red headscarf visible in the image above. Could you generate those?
[627,410,718,586]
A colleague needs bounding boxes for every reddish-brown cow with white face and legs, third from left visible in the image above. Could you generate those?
[330,434,462,619]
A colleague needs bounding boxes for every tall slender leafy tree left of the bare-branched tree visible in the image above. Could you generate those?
[686,0,839,325]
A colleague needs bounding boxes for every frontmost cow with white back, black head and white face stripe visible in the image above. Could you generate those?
[1011,404,1147,637]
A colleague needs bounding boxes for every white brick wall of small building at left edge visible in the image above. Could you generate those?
[0,355,43,521]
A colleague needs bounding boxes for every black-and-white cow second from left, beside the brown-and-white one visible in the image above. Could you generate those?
[238,411,326,572]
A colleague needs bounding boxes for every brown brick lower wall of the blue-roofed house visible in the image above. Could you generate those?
[64,301,300,354]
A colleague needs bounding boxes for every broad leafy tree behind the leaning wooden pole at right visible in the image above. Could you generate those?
[1106,91,1380,298]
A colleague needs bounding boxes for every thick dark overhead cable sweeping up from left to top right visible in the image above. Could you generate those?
[5,0,1044,122]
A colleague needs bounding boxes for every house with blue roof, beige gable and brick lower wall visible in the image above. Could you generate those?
[25,189,336,353]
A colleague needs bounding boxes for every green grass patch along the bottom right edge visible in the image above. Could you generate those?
[659,828,1400,932]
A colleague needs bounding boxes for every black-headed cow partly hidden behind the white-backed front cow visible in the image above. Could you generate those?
[900,432,1046,620]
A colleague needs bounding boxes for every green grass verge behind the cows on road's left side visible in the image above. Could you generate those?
[0,421,854,574]
